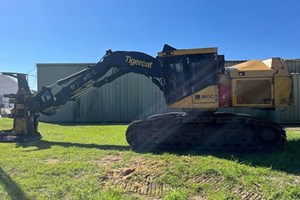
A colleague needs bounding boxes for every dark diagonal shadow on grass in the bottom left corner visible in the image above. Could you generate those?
[0,167,28,200]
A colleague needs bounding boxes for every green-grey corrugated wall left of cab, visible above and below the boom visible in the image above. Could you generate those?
[37,63,177,122]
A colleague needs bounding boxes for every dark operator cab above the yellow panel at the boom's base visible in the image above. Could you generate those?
[158,45,224,105]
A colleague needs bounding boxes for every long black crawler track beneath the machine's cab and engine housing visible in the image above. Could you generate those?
[126,112,286,151]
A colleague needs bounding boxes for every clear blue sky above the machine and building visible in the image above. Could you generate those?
[0,0,300,87]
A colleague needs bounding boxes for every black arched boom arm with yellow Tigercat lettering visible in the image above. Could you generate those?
[26,50,163,115]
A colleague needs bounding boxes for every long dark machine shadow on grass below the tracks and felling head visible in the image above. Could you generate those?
[17,140,300,175]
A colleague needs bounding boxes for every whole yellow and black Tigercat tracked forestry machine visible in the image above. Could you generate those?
[0,45,292,150]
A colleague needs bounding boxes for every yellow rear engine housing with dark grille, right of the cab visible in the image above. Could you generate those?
[227,58,292,108]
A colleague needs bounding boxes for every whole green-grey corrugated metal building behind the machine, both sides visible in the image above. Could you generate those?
[37,60,300,123]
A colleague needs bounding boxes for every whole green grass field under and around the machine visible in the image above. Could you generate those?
[0,118,300,200]
